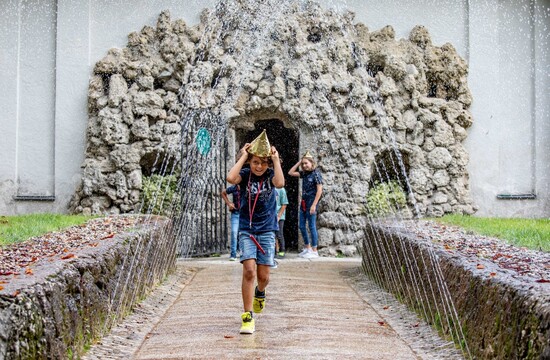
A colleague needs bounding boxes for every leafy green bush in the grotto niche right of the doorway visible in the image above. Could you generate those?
[367,180,407,217]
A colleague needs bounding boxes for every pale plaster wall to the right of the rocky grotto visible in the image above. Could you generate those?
[466,0,550,217]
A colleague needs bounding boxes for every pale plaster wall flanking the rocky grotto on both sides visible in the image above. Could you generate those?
[0,0,550,217]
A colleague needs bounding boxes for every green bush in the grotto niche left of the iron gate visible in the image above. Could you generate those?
[141,174,179,216]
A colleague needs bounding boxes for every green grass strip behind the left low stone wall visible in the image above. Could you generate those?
[0,214,92,246]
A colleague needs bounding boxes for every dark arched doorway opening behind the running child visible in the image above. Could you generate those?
[237,119,299,251]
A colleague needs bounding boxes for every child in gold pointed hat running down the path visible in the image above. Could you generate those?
[227,130,285,334]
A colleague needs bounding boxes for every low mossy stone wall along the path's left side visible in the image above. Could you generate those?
[0,218,175,359]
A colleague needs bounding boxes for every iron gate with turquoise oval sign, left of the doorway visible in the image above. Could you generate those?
[176,115,229,257]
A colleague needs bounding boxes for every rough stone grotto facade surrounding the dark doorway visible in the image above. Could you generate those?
[72,1,475,253]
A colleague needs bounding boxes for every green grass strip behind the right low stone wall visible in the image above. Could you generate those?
[433,215,550,252]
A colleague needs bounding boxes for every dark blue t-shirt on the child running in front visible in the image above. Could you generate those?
[239,168,279,233]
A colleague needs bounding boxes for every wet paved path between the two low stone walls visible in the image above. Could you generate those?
[131,255,420,359]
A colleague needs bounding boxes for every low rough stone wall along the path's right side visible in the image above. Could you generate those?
[363,224,550,359]
